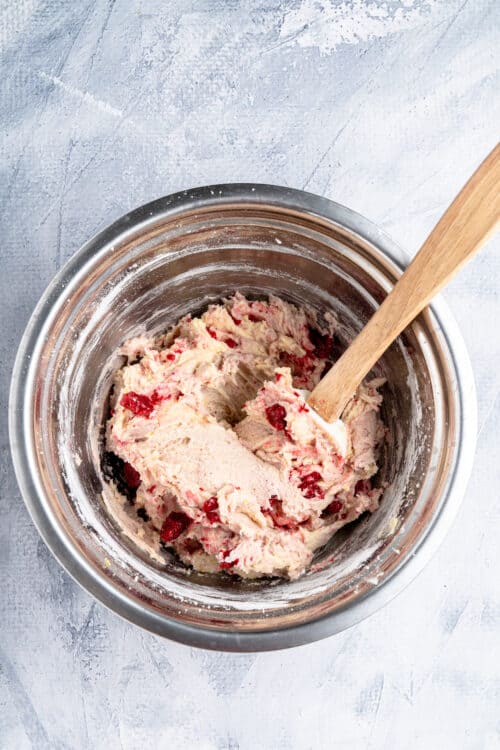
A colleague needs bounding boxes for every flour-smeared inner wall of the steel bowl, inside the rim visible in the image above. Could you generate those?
[26,203,456,631]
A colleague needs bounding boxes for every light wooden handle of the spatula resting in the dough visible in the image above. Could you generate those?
[308,145,500,422]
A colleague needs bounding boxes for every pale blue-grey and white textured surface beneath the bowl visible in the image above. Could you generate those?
[0,0,500,750]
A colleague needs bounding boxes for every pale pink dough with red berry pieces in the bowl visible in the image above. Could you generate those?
[103,293,385,579]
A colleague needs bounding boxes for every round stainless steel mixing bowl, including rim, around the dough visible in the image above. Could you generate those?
[10,184,476,651]
